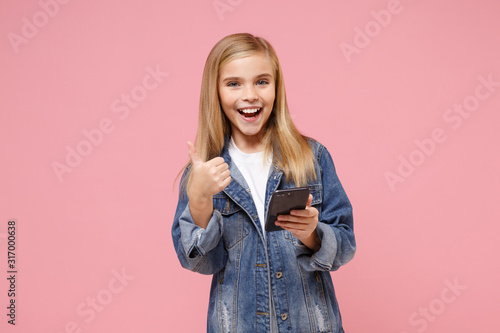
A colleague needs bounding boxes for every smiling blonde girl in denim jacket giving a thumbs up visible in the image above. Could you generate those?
[172,34,356,333]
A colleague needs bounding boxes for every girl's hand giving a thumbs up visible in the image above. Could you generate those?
[187,141,231,206]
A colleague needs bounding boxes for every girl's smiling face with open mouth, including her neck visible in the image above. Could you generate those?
[218,53,275,153]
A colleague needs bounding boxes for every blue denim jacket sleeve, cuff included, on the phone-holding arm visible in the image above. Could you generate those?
[297,146,356,271]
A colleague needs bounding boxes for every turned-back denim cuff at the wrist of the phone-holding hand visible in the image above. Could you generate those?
[297,222,337,271]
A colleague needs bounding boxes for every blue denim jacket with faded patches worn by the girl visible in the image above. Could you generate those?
[172,139,356,333]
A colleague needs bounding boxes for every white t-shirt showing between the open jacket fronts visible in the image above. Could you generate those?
[228,138,272,237]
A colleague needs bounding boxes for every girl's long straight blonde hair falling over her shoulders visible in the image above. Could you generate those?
[184,33,316,186]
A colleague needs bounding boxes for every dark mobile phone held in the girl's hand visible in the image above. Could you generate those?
[266,187,310,231]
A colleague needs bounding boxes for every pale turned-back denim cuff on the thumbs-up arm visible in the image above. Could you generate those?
[179,205,222,259]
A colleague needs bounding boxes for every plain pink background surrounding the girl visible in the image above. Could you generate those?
[0,0,500,333]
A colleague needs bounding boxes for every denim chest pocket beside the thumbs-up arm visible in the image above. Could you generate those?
[213,194,250,250]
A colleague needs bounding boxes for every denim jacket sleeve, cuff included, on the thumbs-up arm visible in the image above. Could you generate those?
[172,169,227,274]
